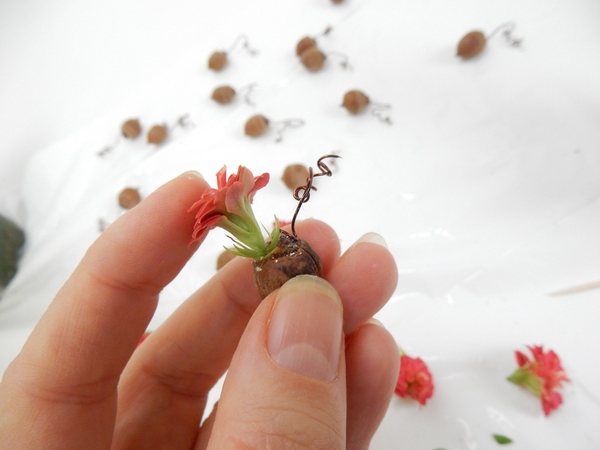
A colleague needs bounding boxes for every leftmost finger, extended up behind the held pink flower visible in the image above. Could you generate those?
[0,173,208,449]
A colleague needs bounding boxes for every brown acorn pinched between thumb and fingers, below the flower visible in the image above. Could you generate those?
[252,230,323,298]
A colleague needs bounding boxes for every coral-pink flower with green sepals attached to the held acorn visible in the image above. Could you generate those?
[188,166,279,259]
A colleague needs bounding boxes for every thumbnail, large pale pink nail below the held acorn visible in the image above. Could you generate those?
[267,275,342,382]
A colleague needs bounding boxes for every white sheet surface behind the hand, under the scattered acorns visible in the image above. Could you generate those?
[0,0,600,450]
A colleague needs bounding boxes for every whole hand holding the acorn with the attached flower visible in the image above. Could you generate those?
[0,172,399,450]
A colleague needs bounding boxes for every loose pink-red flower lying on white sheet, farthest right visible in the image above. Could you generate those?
[508,346,569,415]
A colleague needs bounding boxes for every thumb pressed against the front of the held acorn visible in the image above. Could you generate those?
[208,275,346,450]
